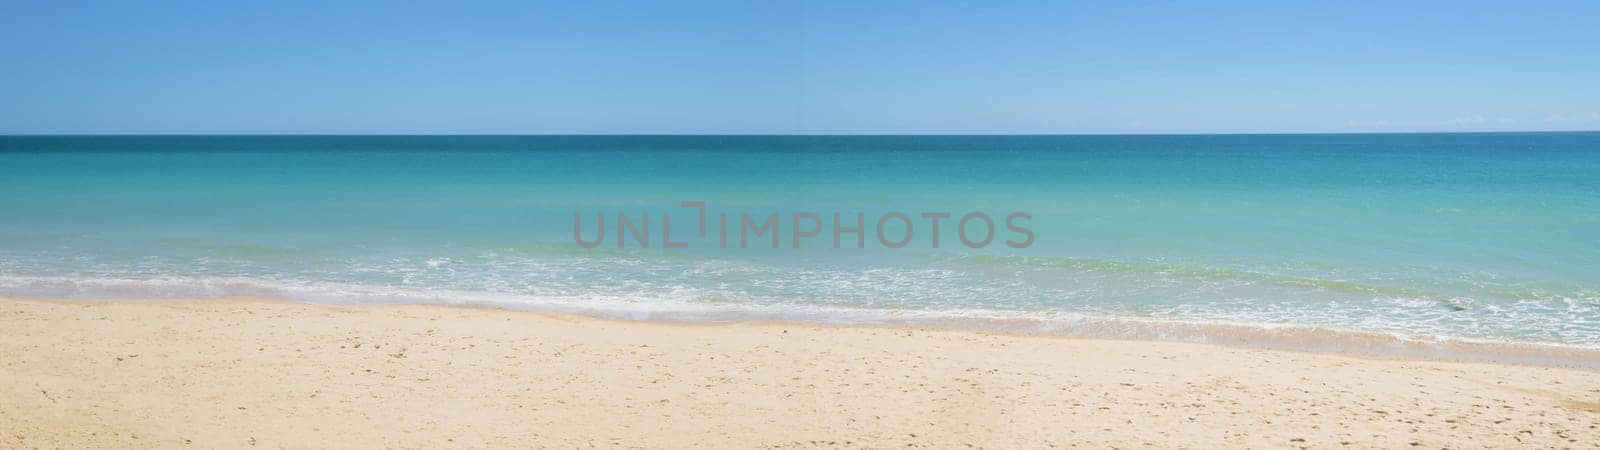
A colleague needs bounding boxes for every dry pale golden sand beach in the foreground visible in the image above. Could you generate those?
[0,299,1600,448]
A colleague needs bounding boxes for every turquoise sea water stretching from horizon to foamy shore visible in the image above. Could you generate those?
[0,133,1600,360]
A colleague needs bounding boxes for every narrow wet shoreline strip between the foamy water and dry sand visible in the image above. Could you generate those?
[0,283,1600,370]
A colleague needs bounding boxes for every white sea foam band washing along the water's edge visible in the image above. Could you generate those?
[0,275,1600,368]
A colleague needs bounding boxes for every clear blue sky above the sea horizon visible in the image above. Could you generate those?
[0,0,1600,133]
